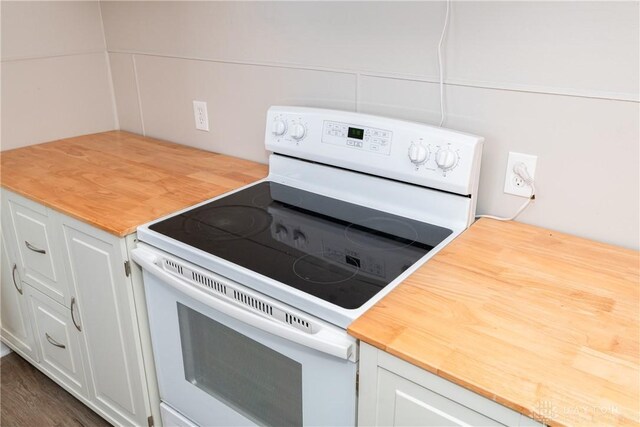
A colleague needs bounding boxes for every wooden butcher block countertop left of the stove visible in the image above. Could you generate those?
[0,131,267,236]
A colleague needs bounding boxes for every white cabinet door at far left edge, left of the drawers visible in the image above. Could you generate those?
[0,229,37,360]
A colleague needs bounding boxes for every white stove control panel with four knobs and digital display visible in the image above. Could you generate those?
[265,107,484,196]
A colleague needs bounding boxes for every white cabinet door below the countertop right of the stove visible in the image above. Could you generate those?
[377,368,503,427]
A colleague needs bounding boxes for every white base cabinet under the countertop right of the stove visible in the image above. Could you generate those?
[358,343,543,427]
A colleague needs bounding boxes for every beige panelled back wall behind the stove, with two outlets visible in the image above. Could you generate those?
[107,1,640,248]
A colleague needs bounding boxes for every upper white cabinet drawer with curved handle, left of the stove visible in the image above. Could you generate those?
[8,194,69,305]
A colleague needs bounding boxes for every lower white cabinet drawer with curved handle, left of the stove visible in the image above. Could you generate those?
[25,286,86,397]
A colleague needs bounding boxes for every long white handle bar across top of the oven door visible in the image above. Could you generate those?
[131,247,357,361]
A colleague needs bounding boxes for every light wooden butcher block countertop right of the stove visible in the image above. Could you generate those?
[349,219,640,426]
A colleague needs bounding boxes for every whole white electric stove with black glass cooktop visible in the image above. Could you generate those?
[134,107,483,426]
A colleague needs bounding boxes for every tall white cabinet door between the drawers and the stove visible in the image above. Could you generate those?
[62,221,149,425]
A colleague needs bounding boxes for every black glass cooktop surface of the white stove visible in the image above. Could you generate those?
[149,182,451,309]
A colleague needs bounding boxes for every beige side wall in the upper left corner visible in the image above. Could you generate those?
[0,1,117,150]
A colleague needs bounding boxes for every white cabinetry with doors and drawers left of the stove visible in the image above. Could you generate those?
[1,189,157,426]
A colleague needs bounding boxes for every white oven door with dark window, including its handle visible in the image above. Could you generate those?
[134,248,357,426]
